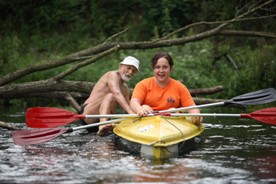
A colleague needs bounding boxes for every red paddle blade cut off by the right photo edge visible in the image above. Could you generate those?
[241,107,276,125]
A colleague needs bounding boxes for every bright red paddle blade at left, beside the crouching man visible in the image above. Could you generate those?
[26,107,85,128]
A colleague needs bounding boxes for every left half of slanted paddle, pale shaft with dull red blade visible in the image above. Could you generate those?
[12,119,123,146]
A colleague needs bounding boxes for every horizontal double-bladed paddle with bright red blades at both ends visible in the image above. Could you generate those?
[26,107,276,128]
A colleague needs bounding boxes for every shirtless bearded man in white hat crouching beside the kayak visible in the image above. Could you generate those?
[81,56,139,136]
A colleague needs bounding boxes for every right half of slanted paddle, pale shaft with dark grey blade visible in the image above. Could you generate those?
[158,88,276,113]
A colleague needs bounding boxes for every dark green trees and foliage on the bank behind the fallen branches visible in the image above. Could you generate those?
[0,0,276,107]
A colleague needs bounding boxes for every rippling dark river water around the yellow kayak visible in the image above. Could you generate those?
[0,107,276,184]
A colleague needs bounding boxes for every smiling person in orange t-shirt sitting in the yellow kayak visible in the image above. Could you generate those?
[130,53,203,124]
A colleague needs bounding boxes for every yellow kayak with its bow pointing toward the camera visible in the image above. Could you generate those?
[113,116,204,159]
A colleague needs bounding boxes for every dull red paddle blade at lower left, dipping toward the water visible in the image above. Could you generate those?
[12,128,72,146]
